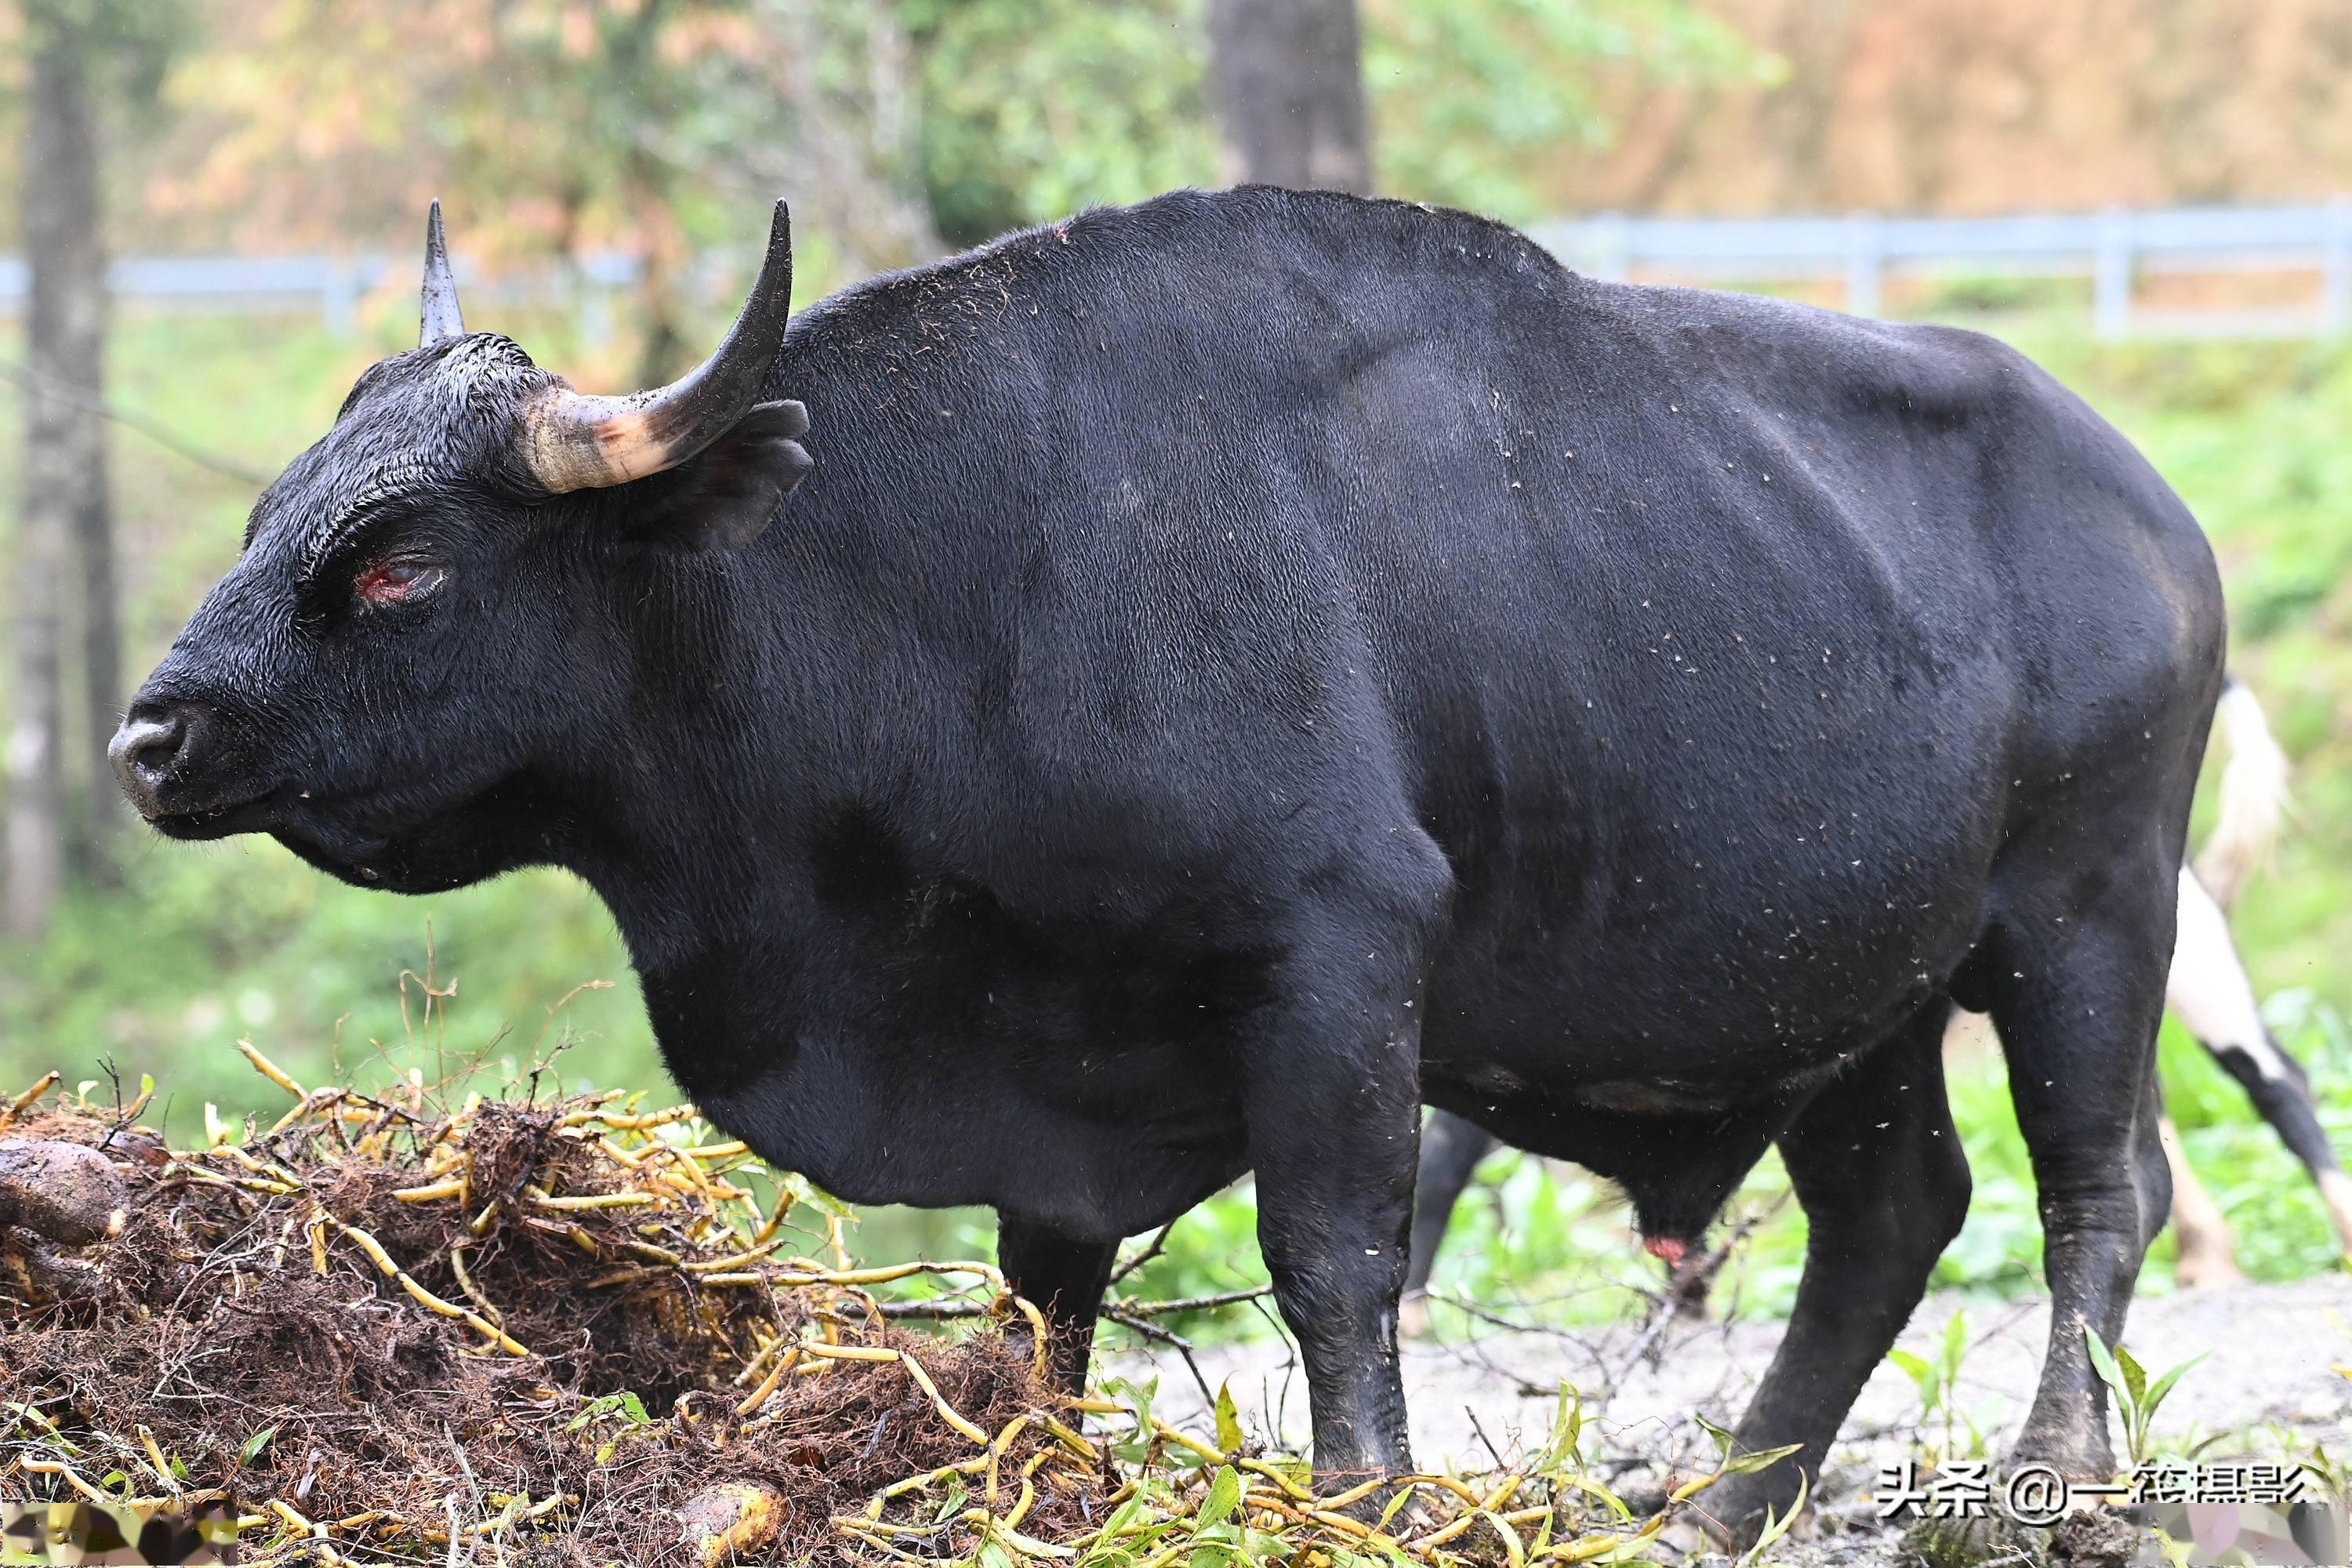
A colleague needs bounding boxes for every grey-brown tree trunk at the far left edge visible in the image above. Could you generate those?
[7,7,118,938]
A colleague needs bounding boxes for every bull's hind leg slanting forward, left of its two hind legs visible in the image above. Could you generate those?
[1698,1004,1969,1535]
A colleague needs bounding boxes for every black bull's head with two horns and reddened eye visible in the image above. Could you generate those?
[108,202,809,891]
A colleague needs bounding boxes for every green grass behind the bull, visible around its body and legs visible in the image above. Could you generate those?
[0,299,2352,1326]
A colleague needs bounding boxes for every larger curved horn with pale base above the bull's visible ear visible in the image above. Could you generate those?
[522,202,793,496]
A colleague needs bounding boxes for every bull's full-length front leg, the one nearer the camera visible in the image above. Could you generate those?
[1242,935,1421,1490]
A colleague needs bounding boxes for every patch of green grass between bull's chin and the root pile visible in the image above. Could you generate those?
[0,844,659,1135]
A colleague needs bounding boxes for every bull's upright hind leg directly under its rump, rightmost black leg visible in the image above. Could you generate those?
[1987,860,2173,1481]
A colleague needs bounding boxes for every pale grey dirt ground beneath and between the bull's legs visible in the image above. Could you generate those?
[1115,1274,2352,1568]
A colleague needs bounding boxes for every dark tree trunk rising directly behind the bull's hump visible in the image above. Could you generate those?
[1209,0,1371,193]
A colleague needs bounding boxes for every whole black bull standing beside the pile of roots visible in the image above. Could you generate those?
[115,188,2223,1514]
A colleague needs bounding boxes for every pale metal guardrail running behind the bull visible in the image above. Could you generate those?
[13,198,2352,339]
